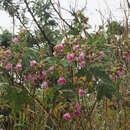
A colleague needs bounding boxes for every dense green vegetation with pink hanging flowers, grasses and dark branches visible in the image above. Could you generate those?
[0,0,130,130]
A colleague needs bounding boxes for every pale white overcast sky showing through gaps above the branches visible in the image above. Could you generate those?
[0,0,130,32]
